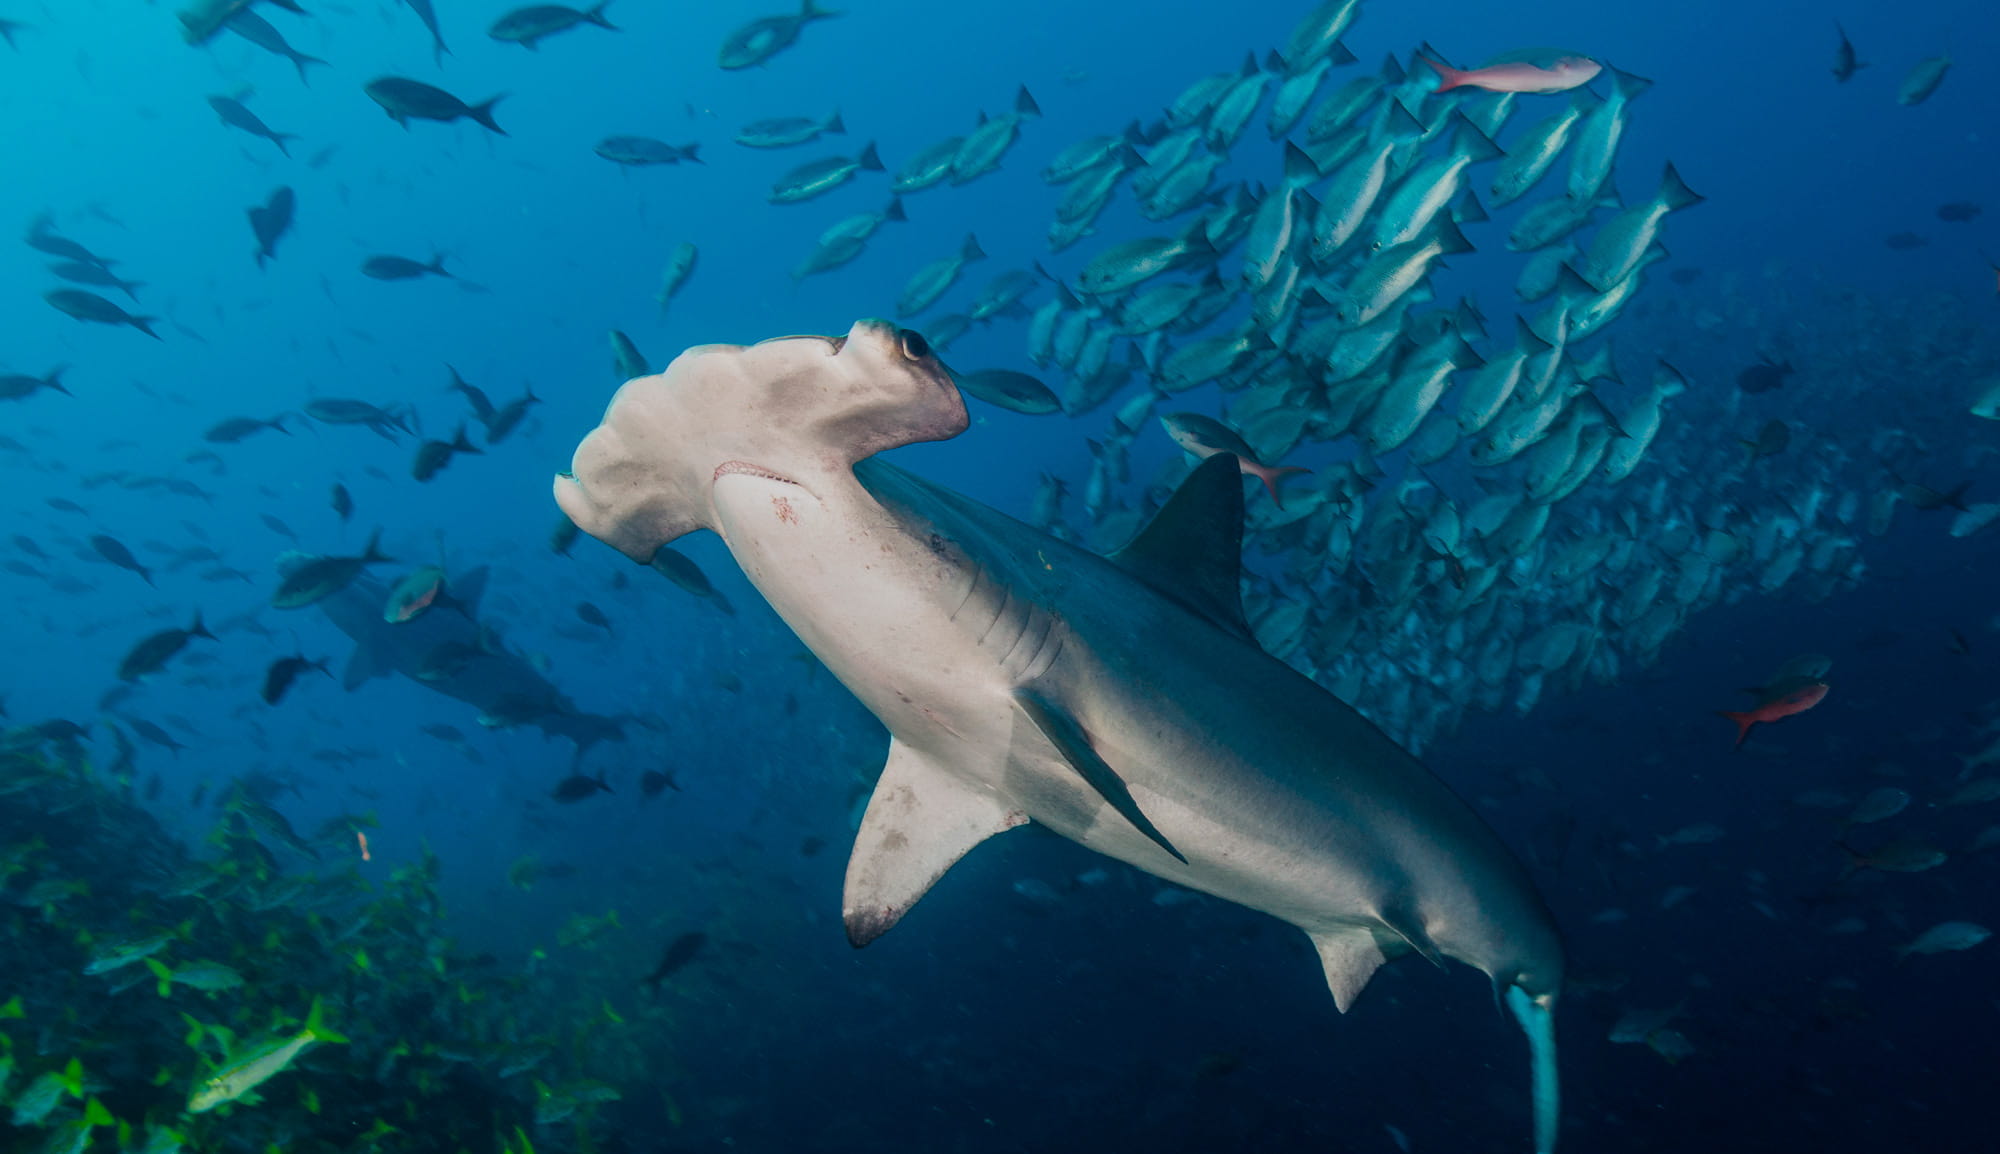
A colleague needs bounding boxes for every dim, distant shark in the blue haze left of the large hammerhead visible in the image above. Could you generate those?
[288,558,624,758]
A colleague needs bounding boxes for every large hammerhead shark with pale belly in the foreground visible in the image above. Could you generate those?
[556,320,1564,1154]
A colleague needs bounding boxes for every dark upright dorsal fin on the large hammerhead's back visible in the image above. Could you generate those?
[1110,452,1252,640]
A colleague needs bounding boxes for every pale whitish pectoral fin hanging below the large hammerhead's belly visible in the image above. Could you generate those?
[840,738,1028,946]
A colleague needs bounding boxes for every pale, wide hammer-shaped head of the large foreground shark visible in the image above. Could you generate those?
[556,320,968,564]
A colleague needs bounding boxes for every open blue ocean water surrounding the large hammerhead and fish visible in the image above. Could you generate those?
[0,0,2000,1152]
